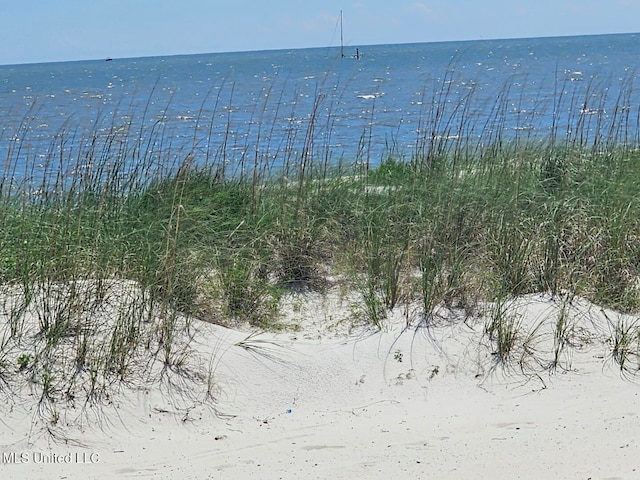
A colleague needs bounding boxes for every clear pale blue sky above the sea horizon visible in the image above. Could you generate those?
[0,0,640,65]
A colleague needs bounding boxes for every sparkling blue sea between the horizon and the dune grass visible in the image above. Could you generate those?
[0,34,640,182]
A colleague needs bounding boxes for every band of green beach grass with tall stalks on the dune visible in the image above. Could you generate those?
[0,72,640,432]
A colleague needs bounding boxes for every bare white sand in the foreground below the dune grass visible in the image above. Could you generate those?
[0,290,640,480]
